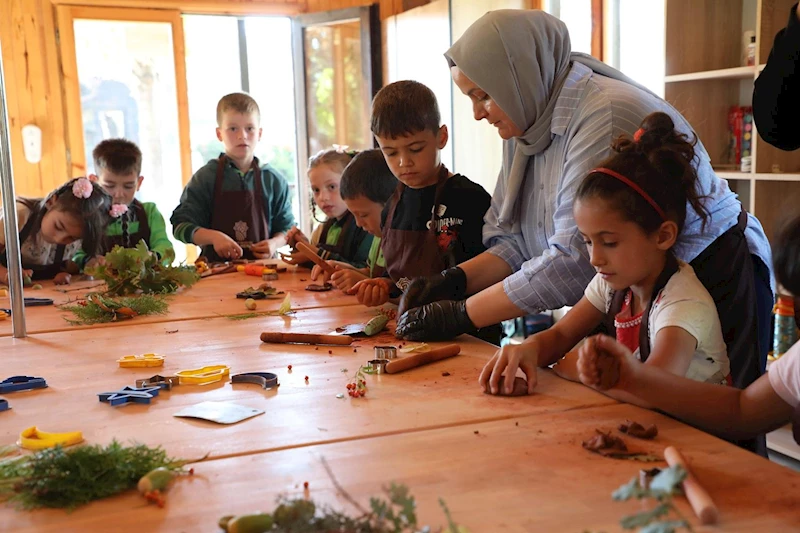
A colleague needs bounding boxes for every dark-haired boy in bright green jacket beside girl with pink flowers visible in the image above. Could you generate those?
[72,139,175,267]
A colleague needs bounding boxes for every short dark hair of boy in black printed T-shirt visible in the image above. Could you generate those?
[371,80,442,139]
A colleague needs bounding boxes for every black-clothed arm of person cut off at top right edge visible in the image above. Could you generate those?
[753,4,800,150]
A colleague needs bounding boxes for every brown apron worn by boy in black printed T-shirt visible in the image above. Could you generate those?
[381,165,450,288]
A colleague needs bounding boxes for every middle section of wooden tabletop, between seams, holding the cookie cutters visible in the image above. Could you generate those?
[0,306,615,457]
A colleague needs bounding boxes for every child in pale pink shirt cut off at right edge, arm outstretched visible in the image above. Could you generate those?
[578,210,800,450]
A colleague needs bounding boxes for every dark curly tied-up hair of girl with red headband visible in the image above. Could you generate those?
[575,112,710,233]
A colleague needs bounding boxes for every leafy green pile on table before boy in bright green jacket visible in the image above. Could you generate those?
[86,240,200,296]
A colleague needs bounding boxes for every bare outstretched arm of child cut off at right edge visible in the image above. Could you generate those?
[578,335,797,438]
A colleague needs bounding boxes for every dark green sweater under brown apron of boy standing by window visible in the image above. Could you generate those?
[170,159,294,244]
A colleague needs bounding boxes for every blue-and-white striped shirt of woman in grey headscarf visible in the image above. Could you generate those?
[483,63,774,313]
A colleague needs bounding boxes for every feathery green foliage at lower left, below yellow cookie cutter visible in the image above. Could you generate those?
[0,441,182,509]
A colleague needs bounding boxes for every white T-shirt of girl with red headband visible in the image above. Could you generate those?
[584,261,730,383]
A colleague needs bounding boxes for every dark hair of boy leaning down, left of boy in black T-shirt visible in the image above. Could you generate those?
[339,150,397,204]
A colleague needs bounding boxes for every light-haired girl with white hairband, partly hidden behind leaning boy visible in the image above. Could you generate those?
[284,146,372,268]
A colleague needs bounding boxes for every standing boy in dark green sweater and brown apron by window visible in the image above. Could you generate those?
[170,93,294,262]
